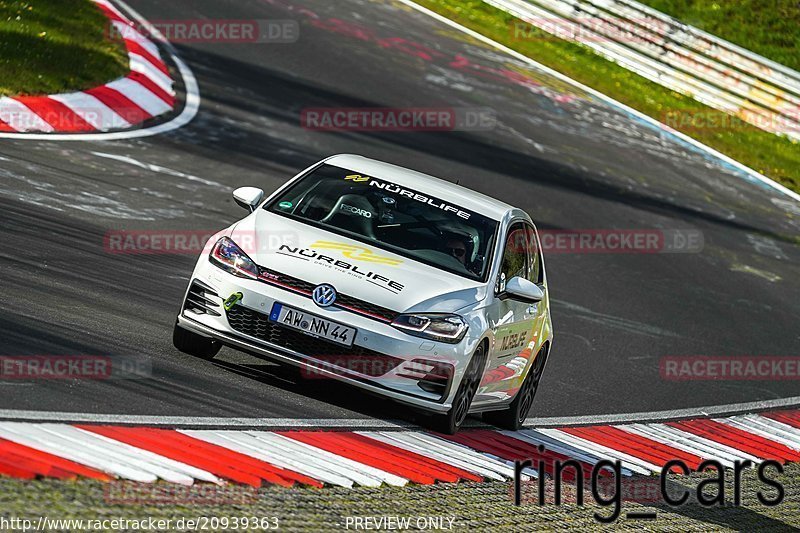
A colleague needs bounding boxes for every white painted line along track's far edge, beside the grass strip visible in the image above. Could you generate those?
[398,0,800,202]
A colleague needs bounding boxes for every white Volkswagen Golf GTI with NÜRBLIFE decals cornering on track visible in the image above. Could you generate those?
[173,155,553,433]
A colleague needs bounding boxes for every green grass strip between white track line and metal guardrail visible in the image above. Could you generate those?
[417,0,800,192]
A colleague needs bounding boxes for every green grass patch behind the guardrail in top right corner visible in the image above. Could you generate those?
[639,0,800,70]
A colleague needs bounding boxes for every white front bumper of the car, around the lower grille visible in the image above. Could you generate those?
[178,258,476,412]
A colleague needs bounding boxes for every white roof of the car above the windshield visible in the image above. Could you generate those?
[325,154,515,220]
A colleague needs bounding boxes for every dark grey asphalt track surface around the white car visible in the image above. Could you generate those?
[0,0,800,420]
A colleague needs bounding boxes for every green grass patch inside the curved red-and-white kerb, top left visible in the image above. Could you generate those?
[0,0,128,95]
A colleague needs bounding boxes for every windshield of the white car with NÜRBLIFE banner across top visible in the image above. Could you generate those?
[265,165,497,281]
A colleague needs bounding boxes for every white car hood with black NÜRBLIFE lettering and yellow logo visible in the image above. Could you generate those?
[231,209,486,313]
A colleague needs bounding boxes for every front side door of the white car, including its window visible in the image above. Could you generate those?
[475,221,541,402]
